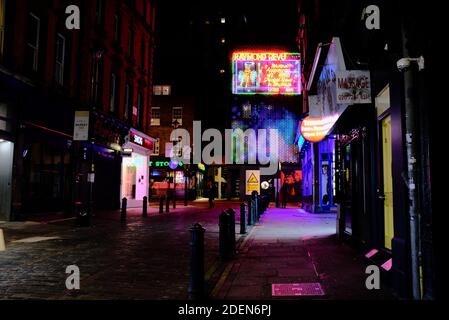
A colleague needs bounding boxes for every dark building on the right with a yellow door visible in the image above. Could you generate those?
[298,0,442,299]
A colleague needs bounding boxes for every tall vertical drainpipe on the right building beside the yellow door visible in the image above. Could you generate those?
[402,22,421,300]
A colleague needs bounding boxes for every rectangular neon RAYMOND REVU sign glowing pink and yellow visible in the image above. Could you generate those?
[232,51,301,95]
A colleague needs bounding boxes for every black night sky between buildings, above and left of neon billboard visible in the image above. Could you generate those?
[154,0,298,128]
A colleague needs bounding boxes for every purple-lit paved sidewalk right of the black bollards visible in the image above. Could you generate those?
[211,208,392,300]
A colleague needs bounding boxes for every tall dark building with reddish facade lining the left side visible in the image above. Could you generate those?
[0,0,155,219]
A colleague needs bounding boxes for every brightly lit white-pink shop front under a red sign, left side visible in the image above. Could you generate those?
[120,129,155,208]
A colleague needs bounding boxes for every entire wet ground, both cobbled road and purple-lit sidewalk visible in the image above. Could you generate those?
[0,201,391,300]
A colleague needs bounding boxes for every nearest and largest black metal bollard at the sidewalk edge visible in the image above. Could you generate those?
[189,223,206,299]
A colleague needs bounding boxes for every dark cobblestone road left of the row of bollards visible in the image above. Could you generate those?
[0,202,243,299]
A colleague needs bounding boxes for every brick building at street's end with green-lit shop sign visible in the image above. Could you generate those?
[149,85,205,201]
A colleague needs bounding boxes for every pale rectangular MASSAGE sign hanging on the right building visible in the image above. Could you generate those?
[336,70,371,104]
